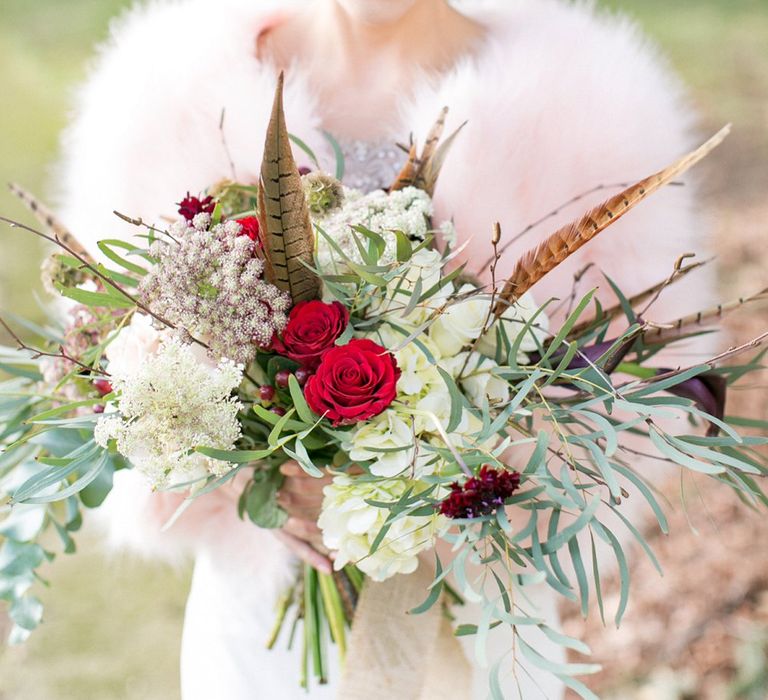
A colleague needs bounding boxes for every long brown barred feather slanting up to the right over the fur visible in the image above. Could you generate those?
[494,125,730,316]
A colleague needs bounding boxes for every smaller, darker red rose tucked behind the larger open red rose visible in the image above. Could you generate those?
[274,300,349,369]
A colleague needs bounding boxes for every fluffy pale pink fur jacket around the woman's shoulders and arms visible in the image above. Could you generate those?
[60,0,711,575]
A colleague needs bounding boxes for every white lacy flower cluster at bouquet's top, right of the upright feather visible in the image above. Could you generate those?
[315,187,432,273]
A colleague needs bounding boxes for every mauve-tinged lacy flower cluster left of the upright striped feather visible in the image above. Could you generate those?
[140,214,291,364]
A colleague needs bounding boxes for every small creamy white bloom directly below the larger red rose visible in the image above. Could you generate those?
[342,409,415,477]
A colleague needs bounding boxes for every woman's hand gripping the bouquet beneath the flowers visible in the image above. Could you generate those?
[275,461,332,574]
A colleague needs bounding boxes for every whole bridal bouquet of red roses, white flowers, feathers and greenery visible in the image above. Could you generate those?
[0,74,768,697]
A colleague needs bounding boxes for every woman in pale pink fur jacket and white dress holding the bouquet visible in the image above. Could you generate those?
[61,0,709,700]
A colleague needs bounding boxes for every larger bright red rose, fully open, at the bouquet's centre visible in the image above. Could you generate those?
[304,339,400,426]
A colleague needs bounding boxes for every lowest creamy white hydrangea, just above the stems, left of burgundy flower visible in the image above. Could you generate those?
[317,474,447,581]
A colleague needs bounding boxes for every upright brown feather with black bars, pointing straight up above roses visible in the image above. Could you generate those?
[261,73,320,303]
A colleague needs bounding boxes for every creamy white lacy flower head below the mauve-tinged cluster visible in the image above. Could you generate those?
[94,337,242,488]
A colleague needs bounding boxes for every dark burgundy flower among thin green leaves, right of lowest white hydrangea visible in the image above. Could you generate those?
[440,464,520,518]
